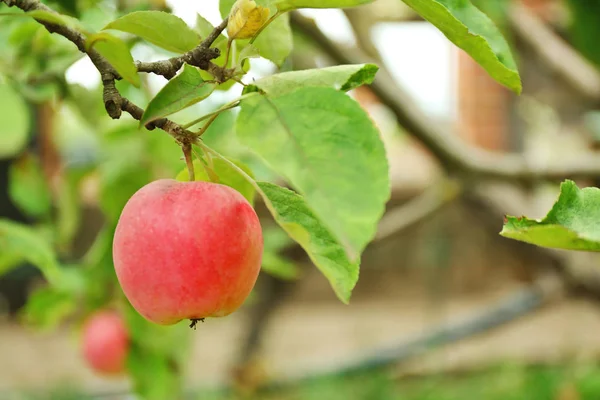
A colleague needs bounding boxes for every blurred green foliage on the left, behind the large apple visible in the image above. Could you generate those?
[0,0,300,400]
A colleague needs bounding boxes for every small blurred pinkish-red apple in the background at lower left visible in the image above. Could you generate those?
[82,310,129,375]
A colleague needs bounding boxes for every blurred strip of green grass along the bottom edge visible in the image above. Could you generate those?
[11,365,600,400]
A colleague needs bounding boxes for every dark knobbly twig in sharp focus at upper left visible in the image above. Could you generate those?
[0,0,227,145]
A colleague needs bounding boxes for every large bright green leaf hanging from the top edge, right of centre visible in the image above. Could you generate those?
[402,0,522,94]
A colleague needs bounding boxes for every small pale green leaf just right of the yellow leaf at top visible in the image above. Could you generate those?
[254,14,294,66]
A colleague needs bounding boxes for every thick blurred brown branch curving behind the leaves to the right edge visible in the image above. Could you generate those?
[291,12,600,182]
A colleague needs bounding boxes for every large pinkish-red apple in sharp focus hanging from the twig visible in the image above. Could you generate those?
[113,179,263,325]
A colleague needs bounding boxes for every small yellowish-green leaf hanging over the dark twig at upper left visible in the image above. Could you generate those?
[85,32,140,87]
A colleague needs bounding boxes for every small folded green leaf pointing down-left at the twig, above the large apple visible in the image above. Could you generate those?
[140,64,216,126]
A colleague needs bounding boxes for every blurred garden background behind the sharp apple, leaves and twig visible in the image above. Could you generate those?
[0,0,600,400]
